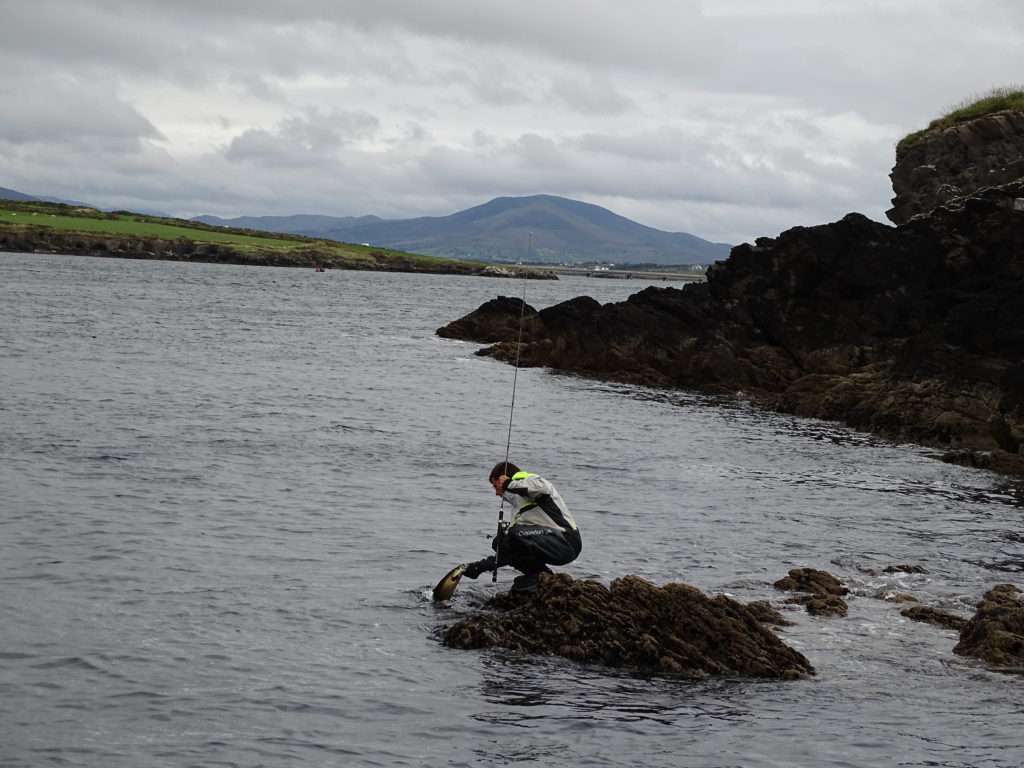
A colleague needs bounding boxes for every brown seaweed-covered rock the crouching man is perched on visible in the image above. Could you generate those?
[443,573,814,679]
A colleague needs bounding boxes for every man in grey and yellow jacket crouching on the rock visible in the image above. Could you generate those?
[464,462,583,592]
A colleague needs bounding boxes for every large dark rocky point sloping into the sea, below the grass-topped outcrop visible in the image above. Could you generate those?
[439,181,1024,474]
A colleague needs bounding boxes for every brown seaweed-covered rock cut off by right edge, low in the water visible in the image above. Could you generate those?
[953,584,1024,668]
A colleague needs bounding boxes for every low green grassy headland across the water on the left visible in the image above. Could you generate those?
[0,201,554,276]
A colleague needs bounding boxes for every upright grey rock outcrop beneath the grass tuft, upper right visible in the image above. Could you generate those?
[886,111,1024,224]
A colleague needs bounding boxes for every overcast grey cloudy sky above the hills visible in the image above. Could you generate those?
[0,0,1024,243]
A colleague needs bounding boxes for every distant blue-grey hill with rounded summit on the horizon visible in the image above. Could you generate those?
[196,195,730,265]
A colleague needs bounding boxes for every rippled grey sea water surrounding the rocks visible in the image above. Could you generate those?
[0,254,1024,767]
